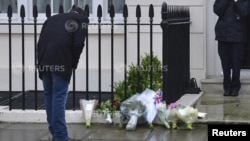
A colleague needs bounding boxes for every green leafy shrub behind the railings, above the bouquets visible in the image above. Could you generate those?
[114,53,162,101]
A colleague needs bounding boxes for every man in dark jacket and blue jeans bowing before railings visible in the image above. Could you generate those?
[38,7,88,141]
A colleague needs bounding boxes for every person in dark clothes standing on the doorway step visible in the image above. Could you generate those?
[213,0,250,96]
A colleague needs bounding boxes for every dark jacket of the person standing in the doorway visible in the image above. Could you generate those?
[213,0,250,43]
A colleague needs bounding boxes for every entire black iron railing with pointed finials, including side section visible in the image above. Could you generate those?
[0,3,190,110]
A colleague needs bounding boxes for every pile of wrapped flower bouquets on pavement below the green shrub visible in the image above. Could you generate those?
[120,89,198,130]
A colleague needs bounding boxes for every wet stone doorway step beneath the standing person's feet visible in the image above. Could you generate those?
[195,93,250,124]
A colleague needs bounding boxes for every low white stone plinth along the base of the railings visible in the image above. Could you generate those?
[0,92,203,124]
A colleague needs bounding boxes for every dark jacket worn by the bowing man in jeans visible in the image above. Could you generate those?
[37,12,89,81]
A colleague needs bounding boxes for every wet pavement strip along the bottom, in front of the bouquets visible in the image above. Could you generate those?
[0,123,207,141]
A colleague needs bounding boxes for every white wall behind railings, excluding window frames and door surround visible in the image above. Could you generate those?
[0,0,207,91]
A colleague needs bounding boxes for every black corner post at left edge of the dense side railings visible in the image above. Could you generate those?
[161,2,168,104]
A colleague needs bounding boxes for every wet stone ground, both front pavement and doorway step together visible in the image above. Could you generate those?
[0,93,250,141]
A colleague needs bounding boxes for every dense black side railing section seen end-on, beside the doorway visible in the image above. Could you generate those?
[161,2,190,104]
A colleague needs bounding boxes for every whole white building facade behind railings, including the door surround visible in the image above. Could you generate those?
[0,0,226,91]
